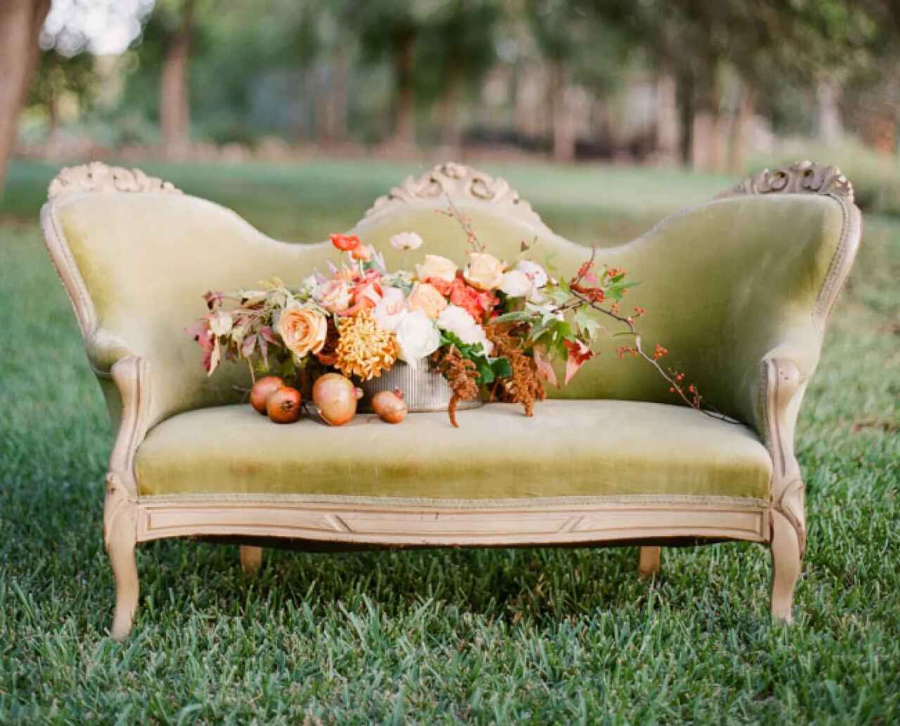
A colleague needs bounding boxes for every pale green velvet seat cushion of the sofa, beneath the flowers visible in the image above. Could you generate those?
[135,400,772,500]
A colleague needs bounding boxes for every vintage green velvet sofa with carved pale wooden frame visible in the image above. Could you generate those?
[42,162,861,638]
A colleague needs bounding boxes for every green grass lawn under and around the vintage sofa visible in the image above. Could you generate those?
[0,162,900,724]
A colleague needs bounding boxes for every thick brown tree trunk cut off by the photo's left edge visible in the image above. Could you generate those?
[0,0,50,194]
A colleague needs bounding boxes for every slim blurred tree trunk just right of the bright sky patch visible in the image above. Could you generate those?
[159,0,194,158]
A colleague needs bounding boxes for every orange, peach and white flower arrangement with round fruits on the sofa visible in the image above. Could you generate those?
[187,204,719,426]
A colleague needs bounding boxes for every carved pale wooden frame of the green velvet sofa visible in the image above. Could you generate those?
[42,162,861,639]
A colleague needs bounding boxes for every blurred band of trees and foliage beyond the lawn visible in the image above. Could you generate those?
[0,0,900,213]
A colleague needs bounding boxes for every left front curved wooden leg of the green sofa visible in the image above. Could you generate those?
[103,474,139,640]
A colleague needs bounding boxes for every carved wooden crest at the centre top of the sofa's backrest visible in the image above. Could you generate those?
[365,162,543,229]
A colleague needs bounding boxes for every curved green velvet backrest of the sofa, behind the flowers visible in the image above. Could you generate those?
[42,164,855,432]
